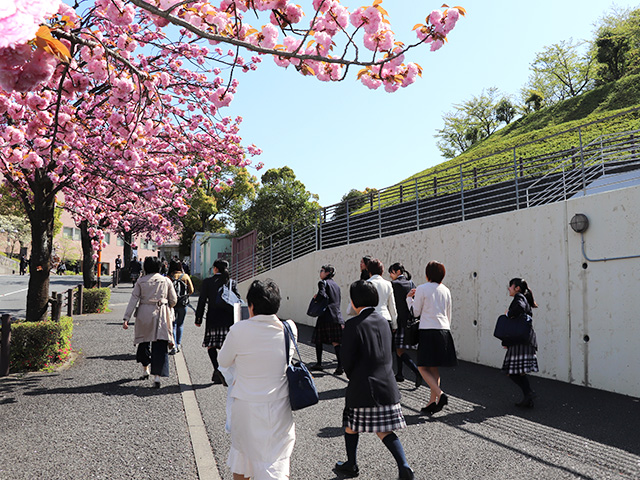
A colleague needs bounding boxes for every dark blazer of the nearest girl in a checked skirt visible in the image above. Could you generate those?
[341,307,400,408]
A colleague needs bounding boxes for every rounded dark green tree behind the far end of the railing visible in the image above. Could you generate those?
[235,166,320,240]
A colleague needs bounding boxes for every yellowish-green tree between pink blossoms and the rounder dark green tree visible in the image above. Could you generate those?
[180,167,258,256]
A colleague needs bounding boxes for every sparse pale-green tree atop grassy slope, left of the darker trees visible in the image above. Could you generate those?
[526,40,594,104]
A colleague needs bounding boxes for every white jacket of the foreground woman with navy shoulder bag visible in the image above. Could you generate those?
[218,315,298,402]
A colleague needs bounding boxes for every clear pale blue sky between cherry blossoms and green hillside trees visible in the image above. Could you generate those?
[225,0,639,206]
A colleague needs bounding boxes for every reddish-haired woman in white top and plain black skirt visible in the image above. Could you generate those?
[407,261,458,415]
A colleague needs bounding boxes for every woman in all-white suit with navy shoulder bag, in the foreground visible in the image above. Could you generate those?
[219,280,297,480]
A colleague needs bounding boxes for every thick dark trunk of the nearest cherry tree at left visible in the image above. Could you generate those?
[25,184,55,322]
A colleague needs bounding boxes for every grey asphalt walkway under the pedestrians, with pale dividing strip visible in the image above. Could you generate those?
[0,285,640,480]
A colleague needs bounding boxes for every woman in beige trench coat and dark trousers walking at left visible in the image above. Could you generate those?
[122,257,178,388]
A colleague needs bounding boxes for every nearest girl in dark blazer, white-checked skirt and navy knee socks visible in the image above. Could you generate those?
[335,280,414,479]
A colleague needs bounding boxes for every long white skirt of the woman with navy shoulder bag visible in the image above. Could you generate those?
[227,397,296,480]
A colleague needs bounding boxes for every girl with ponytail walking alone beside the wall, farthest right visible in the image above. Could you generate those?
[502,278,538,408]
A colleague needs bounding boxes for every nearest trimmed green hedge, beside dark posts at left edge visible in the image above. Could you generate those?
[10,317,73,372]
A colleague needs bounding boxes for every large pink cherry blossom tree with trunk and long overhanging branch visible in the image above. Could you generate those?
[0,0,464,320]
